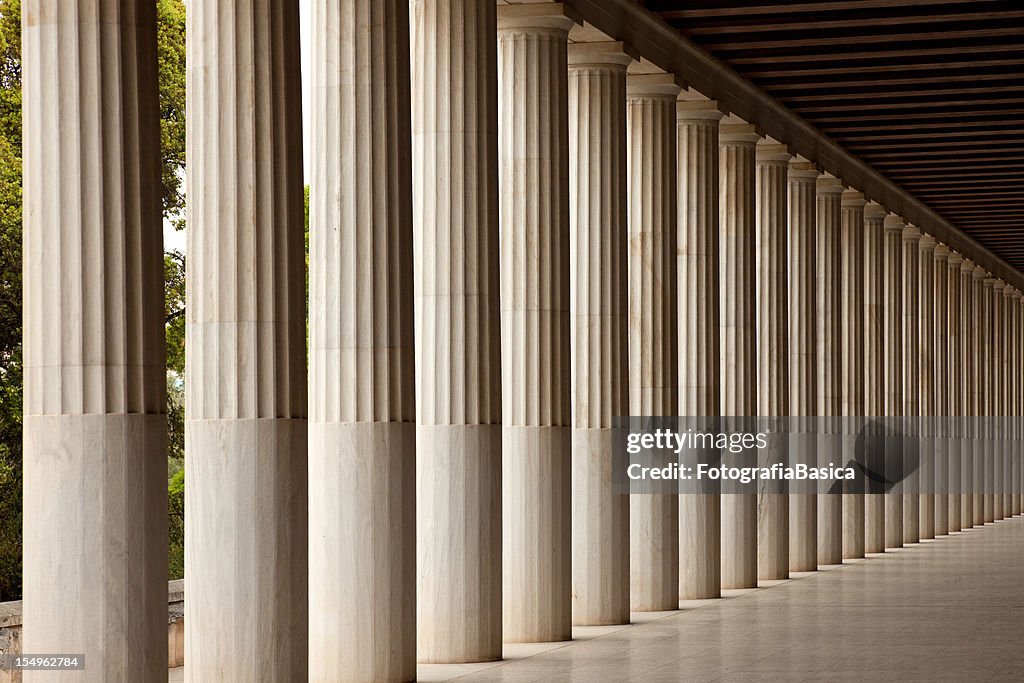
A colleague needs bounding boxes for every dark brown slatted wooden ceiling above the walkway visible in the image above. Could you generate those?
[642,0,1024,271]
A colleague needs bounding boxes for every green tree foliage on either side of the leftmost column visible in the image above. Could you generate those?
[0,0,185,600]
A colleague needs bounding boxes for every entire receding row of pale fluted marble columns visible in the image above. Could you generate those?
[24,0,1024,681]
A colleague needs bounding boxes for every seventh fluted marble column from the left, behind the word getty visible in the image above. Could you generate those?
[626,74,680,611]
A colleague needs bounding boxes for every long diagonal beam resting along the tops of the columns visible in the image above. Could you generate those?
[567,0,1024,290]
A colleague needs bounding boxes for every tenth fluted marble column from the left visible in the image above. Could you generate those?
[756,142,793,580]
